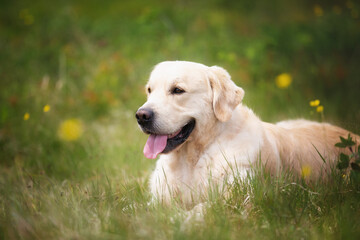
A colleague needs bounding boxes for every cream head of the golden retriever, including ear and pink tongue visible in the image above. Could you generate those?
[136,61,244,158]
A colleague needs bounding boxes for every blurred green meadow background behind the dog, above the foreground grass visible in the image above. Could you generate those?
[0,0,360,178]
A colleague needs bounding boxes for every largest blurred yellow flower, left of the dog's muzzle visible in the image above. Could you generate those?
[58,118,84,141]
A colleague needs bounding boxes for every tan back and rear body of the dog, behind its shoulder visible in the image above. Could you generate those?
[264,119,360,177]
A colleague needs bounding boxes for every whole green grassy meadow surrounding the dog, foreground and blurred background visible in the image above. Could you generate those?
[0,0,360,239]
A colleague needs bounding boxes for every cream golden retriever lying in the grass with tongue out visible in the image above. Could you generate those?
[136,61,359,205]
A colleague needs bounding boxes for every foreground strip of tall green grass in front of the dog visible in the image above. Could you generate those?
[0,158,360,239]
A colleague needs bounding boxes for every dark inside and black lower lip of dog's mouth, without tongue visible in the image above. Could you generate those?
[162,119,196,153]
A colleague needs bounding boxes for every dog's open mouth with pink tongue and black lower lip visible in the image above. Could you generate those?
[144,119,195,159]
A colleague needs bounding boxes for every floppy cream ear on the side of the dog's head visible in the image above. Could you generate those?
[209,66,245,122]
